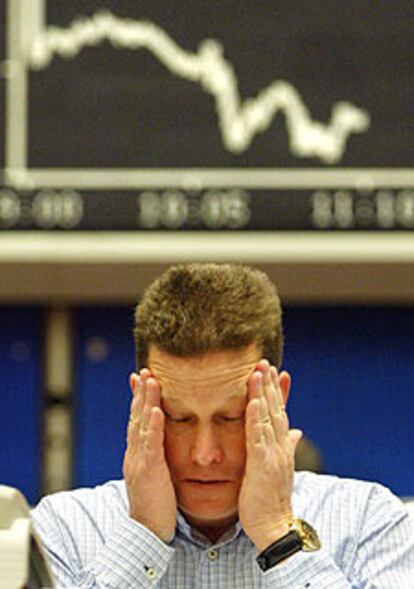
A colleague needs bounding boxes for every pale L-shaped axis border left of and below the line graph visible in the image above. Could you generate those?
[5,0,414,190]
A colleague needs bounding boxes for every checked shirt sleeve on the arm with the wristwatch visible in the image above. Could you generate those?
[262,485,414,589]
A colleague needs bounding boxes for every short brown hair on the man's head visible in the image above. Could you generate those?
[134,263,283,369]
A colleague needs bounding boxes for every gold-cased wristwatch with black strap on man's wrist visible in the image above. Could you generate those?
[256,518,321,571]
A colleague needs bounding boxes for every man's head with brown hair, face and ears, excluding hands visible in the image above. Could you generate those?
[131,264,290,537]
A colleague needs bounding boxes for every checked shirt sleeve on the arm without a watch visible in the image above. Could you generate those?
[32,498,174,589]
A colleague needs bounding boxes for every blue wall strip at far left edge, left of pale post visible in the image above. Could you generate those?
[0,307,42,503]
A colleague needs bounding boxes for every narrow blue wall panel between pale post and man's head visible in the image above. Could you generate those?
[74,308,135,486]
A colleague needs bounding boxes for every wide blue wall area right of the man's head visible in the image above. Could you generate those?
[284,308,414,495]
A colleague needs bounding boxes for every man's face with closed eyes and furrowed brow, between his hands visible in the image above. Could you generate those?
[149,344,260,527]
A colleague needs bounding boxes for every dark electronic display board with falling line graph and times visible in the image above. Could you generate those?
[0,0,414,232]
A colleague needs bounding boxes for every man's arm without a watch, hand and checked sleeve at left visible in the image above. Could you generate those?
[32,369,177,589]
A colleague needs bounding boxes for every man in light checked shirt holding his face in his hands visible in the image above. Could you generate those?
[33,264,414,589]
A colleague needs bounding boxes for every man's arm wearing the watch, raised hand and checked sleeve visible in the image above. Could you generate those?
[239,361,414,589]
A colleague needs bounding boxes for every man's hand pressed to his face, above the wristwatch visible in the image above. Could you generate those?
[239,360,302,551]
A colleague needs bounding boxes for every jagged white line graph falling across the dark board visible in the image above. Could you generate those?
[27,11,370,164]
